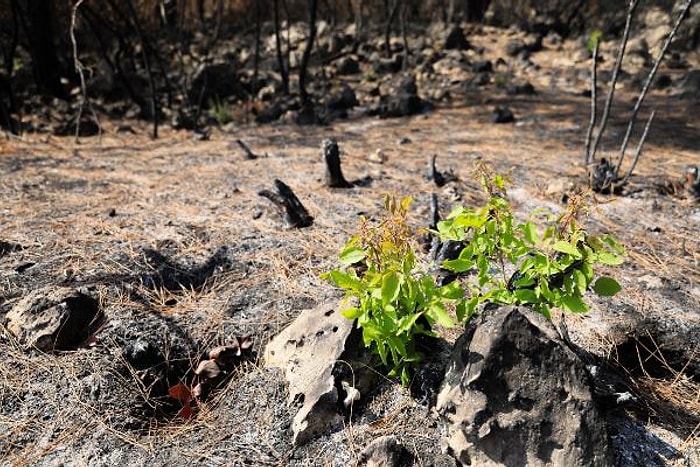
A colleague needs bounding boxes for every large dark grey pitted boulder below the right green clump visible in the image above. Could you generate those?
[436,307,612,466]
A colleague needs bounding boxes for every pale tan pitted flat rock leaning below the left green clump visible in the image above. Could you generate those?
[265,303,353,446]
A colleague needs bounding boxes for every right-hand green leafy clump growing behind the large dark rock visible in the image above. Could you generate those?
[437,163,624,321]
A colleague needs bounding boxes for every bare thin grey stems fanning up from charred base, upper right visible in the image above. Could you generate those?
[584,0,693,193]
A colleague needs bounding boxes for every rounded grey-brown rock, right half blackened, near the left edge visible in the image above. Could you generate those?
[7,286,100,352]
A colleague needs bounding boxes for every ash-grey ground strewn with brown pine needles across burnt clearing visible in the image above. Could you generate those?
[0,29,700,466]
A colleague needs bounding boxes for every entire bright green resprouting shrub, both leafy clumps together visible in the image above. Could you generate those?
[322,163,624,386]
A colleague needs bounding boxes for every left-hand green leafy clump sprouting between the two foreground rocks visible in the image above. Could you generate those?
[322,196,462,386]
